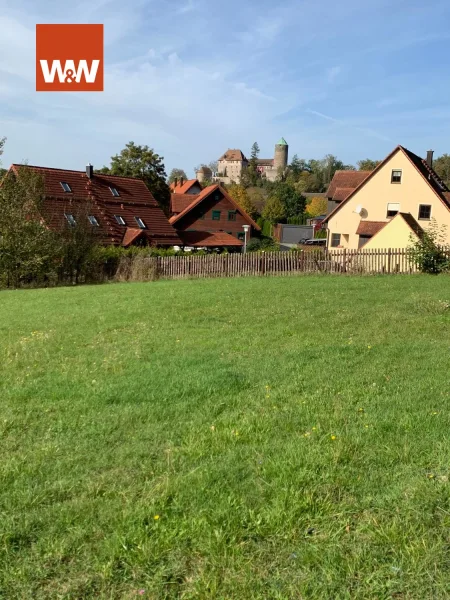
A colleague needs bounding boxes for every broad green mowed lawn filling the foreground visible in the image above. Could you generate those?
[0,276,450,600]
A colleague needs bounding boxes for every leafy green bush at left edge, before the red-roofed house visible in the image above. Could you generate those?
[0,167,62,287]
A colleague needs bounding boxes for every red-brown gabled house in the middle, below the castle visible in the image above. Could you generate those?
[169,184,261,249]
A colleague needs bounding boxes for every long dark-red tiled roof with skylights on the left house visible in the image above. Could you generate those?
[9,164,181,248]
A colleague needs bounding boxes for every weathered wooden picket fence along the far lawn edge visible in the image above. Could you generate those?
[139,248,438,279]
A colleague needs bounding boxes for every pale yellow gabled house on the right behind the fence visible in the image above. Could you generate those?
[325,146,450,249]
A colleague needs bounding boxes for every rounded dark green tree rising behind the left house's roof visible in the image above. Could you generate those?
[100,142,170,214]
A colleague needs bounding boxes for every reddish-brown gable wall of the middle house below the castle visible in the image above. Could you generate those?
[174,190,255,239]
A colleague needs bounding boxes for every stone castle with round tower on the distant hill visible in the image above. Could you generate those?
[214,138,289,184]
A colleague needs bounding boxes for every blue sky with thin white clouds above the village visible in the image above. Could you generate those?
[0,0,450,176]
